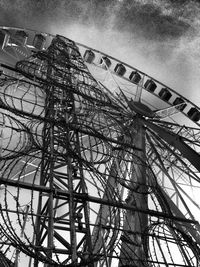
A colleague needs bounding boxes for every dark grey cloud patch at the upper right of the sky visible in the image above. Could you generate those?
[108,1,191,40]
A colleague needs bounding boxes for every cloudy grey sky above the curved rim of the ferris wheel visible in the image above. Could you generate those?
[0,0,200,105]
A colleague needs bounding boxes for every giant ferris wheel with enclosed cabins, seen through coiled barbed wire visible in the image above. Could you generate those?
[0,27,200,267]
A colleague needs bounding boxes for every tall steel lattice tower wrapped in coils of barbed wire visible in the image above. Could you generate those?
[16,36,93,267]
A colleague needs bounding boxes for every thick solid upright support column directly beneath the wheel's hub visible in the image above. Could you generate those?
[119,120,148,267]
